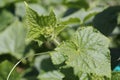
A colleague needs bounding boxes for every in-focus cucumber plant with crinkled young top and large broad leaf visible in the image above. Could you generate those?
[8,3,120,80]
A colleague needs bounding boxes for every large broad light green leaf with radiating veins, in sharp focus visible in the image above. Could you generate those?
[50,27,111,78]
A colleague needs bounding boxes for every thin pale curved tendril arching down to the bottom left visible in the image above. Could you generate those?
[7,51,53,80]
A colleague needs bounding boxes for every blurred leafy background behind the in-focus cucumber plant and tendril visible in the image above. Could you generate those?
[0,0,120,80]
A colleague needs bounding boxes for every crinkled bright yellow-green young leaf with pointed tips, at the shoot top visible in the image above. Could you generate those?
[25,3,64,45]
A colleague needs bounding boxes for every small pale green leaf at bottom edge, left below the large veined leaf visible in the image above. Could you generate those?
[38,71,64,80]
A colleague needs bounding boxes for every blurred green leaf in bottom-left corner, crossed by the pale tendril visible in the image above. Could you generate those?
[0,60,20,80]
